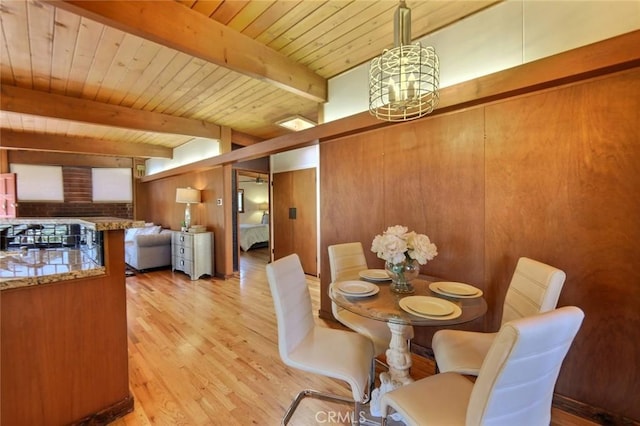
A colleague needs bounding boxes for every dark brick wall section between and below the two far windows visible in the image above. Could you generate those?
[18,166,133,219]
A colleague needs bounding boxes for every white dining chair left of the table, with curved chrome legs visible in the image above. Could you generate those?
[266,254,374,424]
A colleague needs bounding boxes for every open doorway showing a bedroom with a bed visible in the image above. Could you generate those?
[234,169,271,273]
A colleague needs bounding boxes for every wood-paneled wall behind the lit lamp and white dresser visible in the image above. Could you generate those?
[135,166,233,277]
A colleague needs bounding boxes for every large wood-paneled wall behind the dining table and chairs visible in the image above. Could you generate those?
[320,68,640,420]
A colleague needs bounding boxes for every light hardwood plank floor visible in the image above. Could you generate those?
[112,249,593,426]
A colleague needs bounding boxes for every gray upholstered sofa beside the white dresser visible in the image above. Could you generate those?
[124,226,172,271]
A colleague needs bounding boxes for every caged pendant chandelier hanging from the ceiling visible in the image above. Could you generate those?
[369,0,440,121]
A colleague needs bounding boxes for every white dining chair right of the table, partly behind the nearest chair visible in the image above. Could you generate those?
[431,257,566,376]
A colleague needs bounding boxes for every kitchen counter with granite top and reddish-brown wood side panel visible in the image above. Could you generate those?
[0,218,134,425]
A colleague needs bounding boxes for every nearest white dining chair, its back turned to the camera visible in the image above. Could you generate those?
[381,306,584,426]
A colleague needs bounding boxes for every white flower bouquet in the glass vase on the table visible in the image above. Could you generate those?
[371,225,438,265]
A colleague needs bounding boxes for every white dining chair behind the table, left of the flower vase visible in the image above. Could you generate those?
[327,242,413,356]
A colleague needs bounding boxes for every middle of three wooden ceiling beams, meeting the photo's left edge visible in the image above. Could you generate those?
[0,84,220,139]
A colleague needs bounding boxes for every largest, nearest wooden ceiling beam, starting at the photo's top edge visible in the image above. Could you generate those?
[47,0,327,102]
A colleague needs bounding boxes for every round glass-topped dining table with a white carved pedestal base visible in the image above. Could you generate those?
[329,276,487,413]
